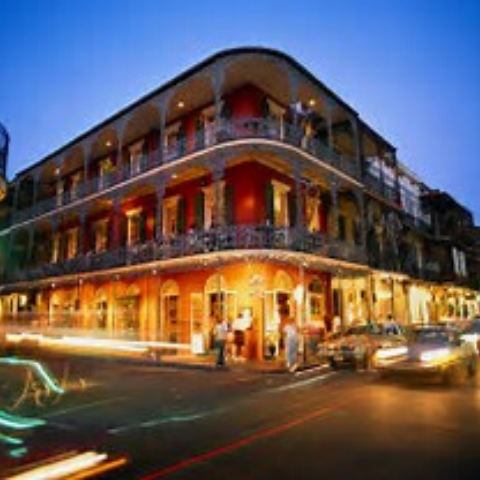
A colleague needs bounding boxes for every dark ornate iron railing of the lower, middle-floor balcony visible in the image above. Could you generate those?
[1,225,366,283]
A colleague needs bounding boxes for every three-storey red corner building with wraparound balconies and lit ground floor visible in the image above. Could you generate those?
[0,48,478,359]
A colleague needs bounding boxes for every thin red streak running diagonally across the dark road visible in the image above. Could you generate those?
[142,397,353,480]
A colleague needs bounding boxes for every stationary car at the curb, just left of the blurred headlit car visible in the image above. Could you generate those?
[320,323,406,369]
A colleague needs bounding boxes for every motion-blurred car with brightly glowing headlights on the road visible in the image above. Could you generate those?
[375,325,478,383]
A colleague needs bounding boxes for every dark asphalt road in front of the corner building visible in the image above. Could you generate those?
[0,352,480,480]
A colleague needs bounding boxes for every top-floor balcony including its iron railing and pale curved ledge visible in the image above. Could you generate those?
[8,117,360,223]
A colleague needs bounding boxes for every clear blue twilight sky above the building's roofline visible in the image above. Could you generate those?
[0,0,480,222]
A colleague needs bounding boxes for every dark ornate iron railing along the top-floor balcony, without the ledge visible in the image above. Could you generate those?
[8,118,359,223]
